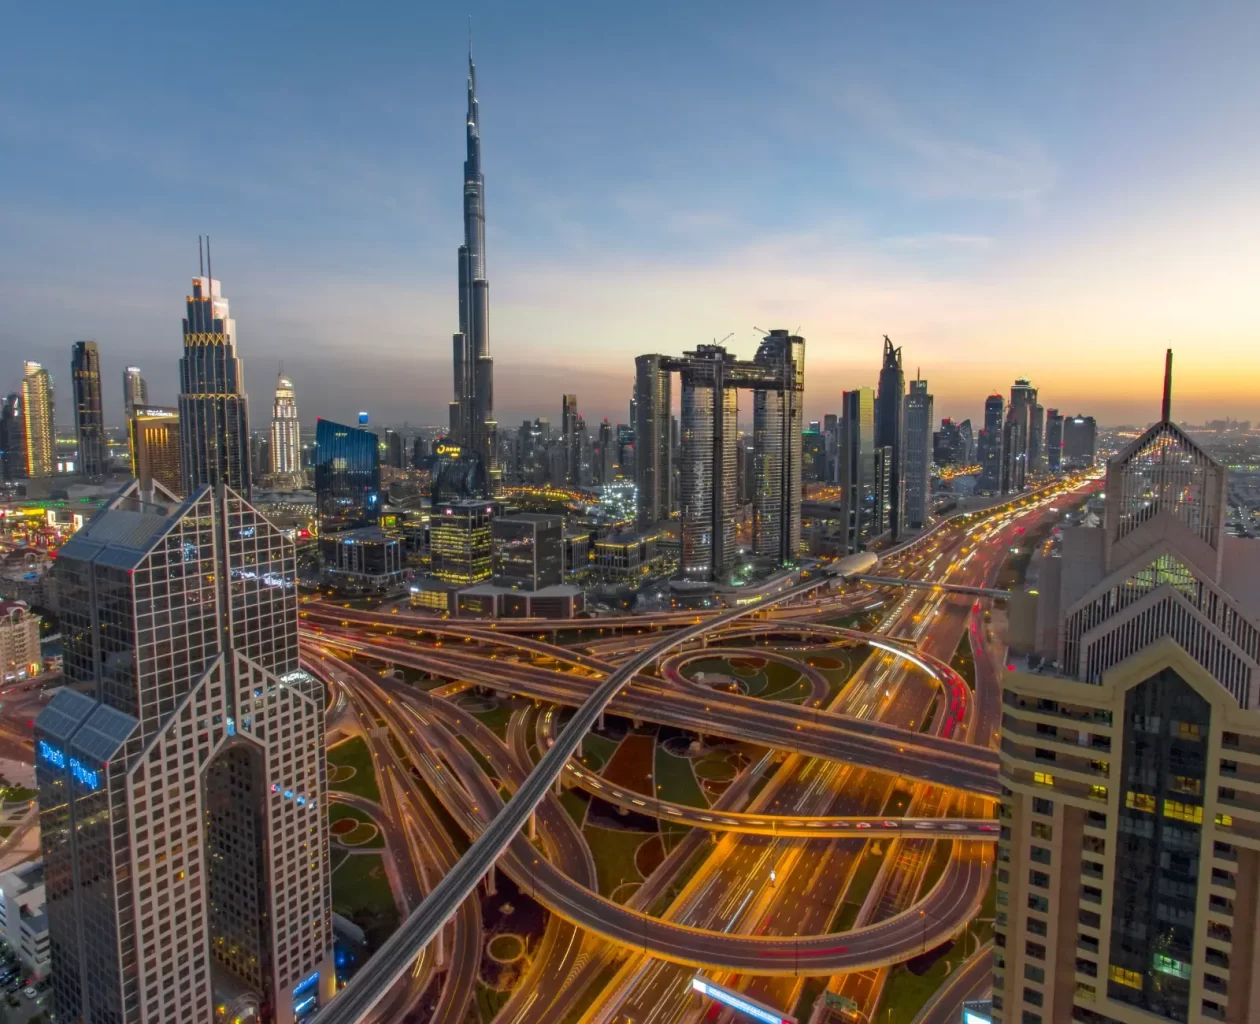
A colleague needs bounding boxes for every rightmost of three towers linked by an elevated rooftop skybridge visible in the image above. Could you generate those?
[752,330,805,564]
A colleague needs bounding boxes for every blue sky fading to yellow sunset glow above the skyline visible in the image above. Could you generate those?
[0,0,1260,424]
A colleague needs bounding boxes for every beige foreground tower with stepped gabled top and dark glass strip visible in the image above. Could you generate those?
[993,350,1260,1024]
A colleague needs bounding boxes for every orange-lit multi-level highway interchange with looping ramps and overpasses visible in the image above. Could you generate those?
[304,478,1093,1024]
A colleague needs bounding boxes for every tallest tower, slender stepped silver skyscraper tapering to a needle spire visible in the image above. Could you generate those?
[451,44,499,489]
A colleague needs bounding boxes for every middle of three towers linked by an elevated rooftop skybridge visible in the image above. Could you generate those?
[678,345,738,579]
